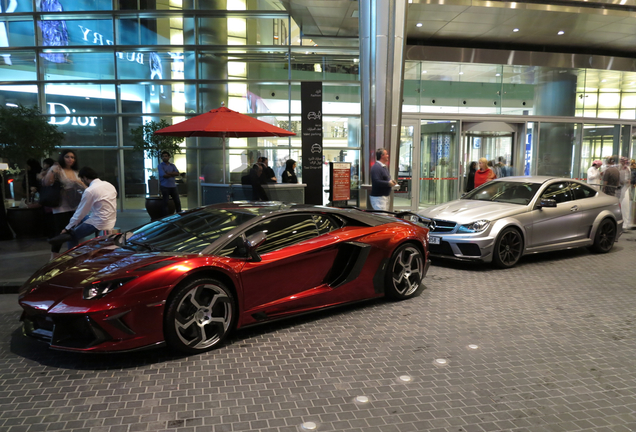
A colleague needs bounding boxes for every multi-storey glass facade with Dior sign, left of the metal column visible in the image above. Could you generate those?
[0,0,361,209]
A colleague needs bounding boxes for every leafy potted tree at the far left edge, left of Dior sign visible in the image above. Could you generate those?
[0,105,64,240]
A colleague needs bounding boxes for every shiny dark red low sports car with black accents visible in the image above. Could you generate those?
[19,203,429,353]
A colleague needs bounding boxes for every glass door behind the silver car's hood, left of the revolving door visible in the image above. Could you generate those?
[417,120,459,208]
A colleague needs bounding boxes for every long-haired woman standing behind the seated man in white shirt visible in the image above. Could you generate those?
[42,150,86,259]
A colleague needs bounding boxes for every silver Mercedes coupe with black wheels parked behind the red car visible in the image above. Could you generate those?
[418,176,623,268]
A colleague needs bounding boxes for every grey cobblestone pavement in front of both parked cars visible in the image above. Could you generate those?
[0,231,636,432]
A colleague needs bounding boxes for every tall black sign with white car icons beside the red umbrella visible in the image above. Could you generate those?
[300,81,323,205]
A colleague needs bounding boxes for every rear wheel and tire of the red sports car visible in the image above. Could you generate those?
[385,243,424,300]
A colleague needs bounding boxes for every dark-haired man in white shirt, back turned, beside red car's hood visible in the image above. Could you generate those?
[48,167,117,247]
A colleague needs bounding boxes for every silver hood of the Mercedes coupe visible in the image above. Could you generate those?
[418,200,527,224]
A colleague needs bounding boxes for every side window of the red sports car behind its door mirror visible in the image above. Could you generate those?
[245,214,318,254]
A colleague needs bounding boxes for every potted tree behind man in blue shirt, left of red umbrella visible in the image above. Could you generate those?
[130,119,183,220]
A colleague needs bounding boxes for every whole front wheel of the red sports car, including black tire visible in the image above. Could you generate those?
[163,278,238,354]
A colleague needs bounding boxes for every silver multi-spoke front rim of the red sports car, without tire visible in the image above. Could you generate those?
[174,284,233,350]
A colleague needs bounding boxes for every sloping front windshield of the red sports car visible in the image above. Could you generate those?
[124,208,257,253]
